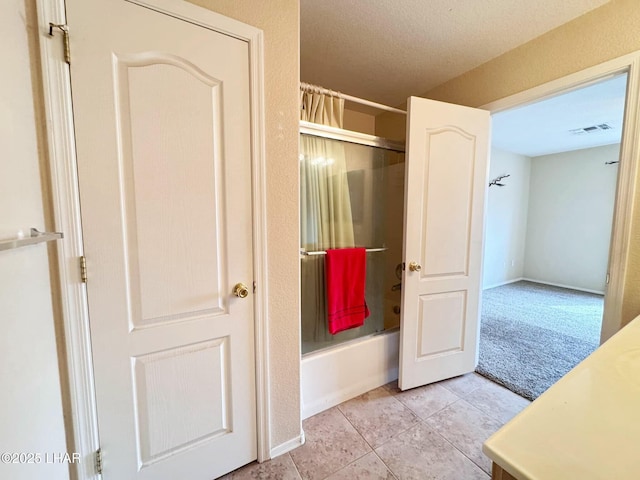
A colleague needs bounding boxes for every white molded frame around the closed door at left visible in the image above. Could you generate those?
[37,0,271,480]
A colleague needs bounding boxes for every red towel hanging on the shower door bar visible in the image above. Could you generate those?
[325,248,369,335]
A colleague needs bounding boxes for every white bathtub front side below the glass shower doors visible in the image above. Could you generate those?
[300,331,400,419]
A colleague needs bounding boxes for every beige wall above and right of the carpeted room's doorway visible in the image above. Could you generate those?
[376,0,640,323]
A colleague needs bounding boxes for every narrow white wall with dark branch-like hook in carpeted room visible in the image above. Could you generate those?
[483,148,531,288]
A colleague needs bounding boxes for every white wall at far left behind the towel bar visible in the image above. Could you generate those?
[0,0,69,480]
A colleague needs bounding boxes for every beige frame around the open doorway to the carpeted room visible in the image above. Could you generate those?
[480,51,640,343]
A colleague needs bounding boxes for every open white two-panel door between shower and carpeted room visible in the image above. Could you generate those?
[398,97,490,390]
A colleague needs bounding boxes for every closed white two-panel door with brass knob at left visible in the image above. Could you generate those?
[67,0,257,480]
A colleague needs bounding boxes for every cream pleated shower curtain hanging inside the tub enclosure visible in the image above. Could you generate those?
[300,85,355,342]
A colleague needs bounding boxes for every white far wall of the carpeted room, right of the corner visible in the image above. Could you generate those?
[524,144,620,292]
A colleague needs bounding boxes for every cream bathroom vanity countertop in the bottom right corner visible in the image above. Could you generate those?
[483,317,640,480]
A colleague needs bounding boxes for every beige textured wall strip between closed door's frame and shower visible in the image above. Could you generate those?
[191,0,300,447]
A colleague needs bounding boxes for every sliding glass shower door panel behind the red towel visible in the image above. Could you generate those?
[300,134,405,354]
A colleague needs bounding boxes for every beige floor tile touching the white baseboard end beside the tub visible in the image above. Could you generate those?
[290,408,371,480]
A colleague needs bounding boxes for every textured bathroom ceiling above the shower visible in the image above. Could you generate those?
[300,0,608,106]
